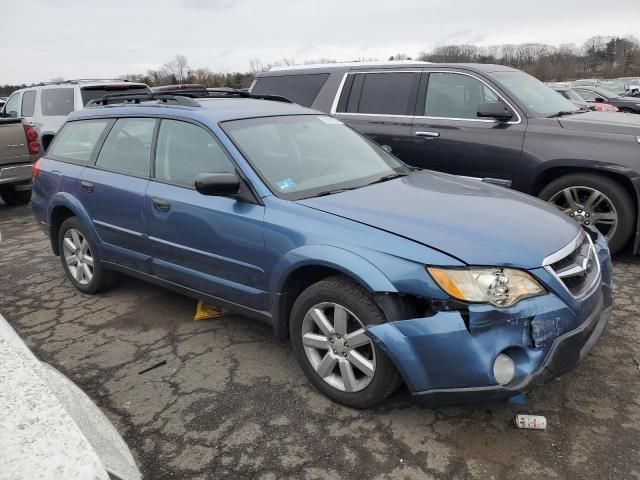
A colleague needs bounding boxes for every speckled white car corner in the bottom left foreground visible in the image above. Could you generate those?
[0,315,142,480]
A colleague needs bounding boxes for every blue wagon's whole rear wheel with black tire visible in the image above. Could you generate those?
[58,217,115,294]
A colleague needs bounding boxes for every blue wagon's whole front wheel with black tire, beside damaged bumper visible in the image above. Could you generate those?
[289,275,401,408]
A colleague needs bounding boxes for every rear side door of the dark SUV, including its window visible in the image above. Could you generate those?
[331,70,420,160]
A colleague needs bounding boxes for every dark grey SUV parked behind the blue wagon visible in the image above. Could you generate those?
[251,61,640,253]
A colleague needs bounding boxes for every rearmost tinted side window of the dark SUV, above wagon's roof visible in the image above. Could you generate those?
[251,73,329,107]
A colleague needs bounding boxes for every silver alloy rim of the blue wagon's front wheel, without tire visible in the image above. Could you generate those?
[302,302,376,392]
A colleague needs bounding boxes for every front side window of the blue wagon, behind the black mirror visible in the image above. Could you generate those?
[155,120,235,188]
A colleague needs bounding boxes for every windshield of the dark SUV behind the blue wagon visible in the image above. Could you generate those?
[493,72,579,117]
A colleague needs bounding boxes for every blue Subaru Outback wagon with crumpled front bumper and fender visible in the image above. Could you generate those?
[32,92,612,408]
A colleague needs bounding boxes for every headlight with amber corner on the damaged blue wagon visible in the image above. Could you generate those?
[427,267,545,307]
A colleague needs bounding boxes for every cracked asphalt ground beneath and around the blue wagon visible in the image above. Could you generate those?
[0,202,640,480]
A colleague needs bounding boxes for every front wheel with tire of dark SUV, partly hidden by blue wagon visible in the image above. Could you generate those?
[538,173,637,254]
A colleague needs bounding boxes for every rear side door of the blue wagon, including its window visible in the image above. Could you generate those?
[76,118,157,272]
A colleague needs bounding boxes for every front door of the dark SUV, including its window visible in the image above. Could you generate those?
[408,69,526,186]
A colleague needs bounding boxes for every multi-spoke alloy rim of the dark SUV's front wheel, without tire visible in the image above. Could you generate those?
[549,186,618,240]
